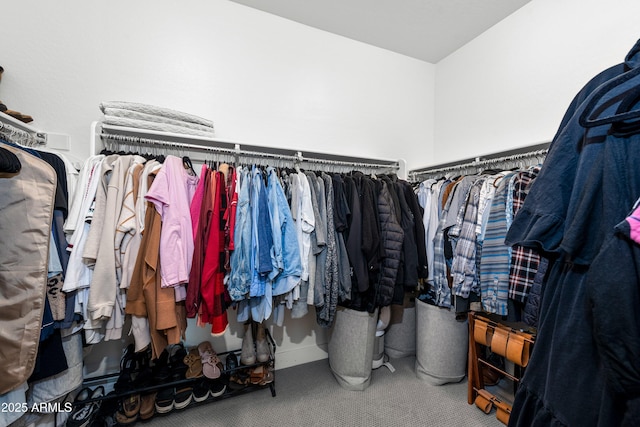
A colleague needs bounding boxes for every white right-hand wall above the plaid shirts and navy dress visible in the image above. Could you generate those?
[432,0,640,166]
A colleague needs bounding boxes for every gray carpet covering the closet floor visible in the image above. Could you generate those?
[145,357,503,427]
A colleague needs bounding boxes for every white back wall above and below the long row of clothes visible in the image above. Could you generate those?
[0,0,435,375]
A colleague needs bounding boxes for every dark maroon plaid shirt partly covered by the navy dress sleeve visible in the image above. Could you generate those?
[509,167,540,302]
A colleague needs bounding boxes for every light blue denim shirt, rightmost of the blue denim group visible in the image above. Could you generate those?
[267,168,302,295]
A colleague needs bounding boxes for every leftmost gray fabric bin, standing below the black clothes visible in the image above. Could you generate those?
[328,307,378,390]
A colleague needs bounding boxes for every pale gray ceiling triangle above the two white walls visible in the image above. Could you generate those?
[232,0,531,64]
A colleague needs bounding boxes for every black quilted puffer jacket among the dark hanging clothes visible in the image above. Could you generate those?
[376,180,404,307]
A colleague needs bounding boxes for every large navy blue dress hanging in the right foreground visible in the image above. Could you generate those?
[506,42,640,426]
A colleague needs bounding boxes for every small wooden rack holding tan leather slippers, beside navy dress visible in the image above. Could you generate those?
[467,312,535,425]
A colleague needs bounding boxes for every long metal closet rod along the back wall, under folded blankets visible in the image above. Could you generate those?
[100,132,399,170]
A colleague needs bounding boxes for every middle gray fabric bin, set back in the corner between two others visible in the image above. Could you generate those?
[384,298,416,359]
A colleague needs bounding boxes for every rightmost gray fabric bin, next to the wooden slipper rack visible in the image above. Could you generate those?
[416,299,469,385]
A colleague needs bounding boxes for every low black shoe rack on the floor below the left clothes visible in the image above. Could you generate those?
[73,329,276,425]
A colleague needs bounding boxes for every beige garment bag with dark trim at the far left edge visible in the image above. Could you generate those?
[0,143,56,394]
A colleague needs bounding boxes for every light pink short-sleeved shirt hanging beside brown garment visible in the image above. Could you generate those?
[145,156,199,292]
